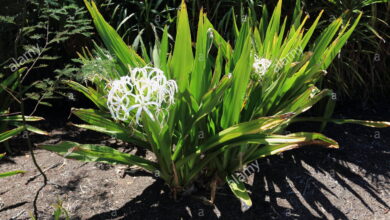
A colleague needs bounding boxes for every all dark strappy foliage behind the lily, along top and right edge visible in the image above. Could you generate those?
[93,0,390,99]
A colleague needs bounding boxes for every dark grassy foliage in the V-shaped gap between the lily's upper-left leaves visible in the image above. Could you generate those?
[97,0,175,49]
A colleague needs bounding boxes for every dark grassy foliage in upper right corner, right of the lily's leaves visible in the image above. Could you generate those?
[305,0,390,99]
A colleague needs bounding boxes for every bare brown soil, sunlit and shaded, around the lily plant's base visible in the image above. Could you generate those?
[0,100,390,220]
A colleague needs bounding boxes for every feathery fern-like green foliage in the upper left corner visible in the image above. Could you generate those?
[0,0,93,106]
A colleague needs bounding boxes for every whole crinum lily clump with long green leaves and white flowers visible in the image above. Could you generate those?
[40,1,389,207]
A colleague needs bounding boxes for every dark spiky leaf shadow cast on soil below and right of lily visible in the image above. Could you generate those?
[90,123,390,219]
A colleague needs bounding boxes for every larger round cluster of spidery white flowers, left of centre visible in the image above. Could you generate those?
[107,67,177,124]
